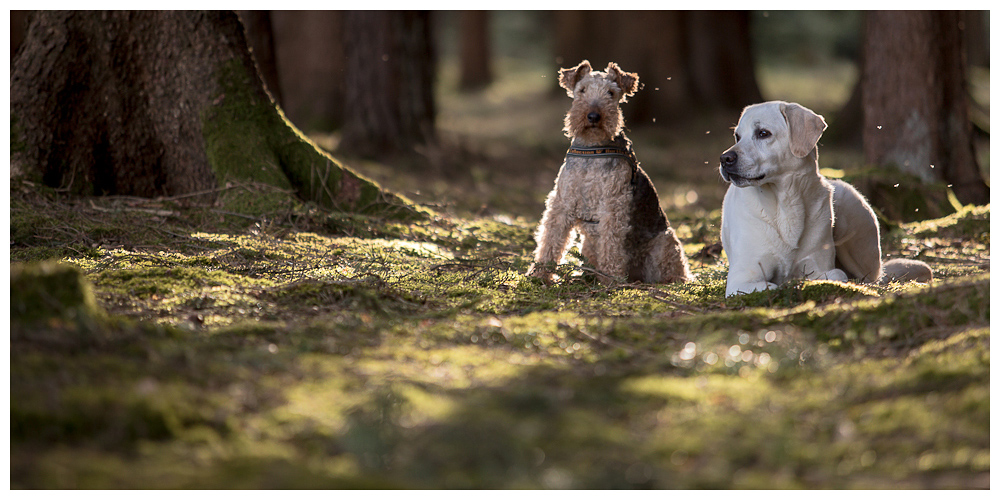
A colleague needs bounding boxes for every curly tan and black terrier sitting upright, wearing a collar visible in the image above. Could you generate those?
[528,61,692,284]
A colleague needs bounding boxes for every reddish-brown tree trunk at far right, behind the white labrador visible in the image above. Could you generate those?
[862,11,989,205]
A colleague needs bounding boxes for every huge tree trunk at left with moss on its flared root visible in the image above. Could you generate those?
[11,11,412,217]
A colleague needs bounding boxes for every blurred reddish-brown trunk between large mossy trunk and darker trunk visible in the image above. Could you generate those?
[271,11,346,130]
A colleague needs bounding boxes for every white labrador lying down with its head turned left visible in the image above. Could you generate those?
[719,101,931,296]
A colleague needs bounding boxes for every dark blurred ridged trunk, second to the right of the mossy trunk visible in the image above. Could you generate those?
[339,11,436,157]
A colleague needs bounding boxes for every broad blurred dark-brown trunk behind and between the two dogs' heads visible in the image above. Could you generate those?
[553,11,761,123]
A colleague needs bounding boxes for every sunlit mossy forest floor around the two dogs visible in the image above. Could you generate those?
[10,59,990,489]
